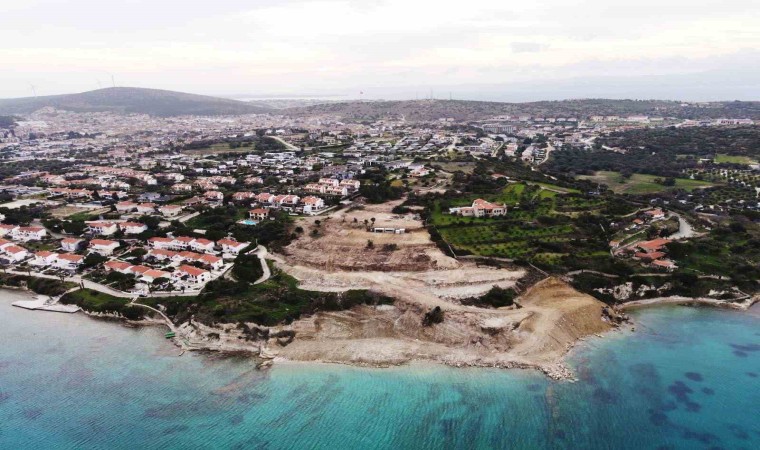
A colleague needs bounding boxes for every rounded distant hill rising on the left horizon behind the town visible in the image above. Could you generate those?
[0,87,270,116]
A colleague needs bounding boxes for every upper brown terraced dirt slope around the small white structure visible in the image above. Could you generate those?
[284,200,458,271]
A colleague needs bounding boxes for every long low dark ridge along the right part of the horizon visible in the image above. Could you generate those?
[283,99,760,121]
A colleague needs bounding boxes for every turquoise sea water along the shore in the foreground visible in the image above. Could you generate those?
[0,292,760,449]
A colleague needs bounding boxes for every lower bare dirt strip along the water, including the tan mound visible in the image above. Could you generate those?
[274,278,612,378]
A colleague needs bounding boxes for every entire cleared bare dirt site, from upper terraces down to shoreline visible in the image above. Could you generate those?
[249,202,612,378]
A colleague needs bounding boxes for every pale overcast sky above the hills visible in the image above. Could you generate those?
[0,0,760,101]
